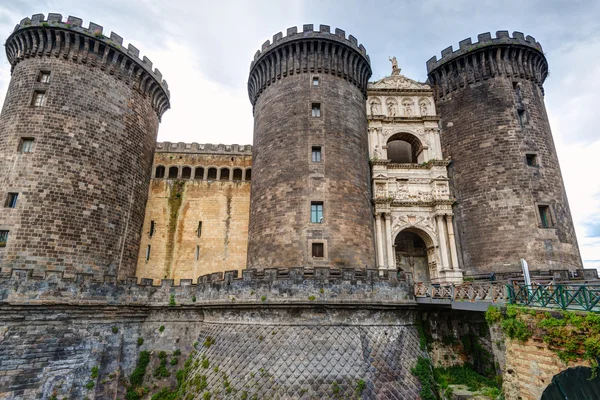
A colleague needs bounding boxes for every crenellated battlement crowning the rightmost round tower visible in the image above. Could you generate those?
[427,31,548,98]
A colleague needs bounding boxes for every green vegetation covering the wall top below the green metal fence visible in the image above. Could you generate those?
[486,305,600,377]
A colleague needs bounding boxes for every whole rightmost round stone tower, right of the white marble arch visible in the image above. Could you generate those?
[427,31,582,272]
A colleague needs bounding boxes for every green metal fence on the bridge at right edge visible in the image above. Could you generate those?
[507,284,600,312]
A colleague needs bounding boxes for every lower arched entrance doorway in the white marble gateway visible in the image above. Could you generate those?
[394,229,431,282]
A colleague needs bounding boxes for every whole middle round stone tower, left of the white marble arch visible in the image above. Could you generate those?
[248,25,375,268]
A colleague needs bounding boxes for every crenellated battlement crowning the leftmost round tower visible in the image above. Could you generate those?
[5,13,170,118]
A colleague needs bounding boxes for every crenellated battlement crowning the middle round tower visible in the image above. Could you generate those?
[248,24,371,105]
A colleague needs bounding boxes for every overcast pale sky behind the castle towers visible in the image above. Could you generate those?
[0,0,600,267]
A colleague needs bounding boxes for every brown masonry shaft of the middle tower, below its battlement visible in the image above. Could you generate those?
[248,73,375,268]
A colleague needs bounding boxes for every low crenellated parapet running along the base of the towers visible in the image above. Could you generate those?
[0,267,414,306]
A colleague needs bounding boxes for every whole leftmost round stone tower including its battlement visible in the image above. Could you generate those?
[0,14,169,277]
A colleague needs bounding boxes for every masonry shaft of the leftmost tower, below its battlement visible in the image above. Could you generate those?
[0,57,158,276]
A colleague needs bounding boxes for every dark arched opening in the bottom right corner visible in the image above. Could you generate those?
[541,367,600,400]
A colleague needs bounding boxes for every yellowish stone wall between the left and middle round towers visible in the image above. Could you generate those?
[136,143,252,280]
